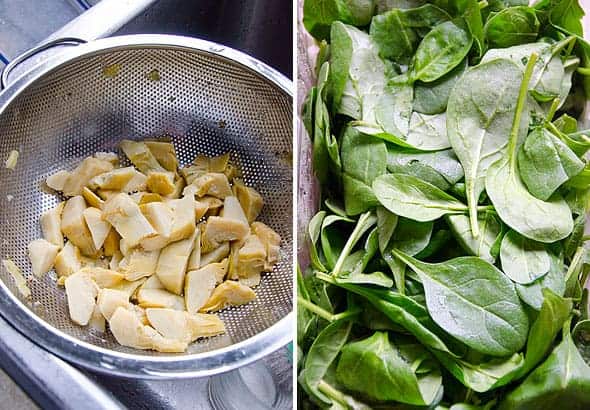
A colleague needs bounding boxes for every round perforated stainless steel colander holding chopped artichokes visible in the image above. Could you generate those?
[0,36,293,377]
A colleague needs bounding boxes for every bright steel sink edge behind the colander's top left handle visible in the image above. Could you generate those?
[0,0,157,90]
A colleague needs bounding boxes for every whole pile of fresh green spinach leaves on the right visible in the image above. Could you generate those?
[297,0,590,410]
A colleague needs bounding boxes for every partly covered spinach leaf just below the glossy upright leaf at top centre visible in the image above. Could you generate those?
[414,60,467,115]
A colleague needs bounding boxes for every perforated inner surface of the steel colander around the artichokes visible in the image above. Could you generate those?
[0,46,293,356]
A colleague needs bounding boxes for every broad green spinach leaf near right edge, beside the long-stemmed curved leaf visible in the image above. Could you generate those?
[518,128,584,201]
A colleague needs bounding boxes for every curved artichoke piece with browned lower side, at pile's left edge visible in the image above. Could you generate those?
[61,195,100,257]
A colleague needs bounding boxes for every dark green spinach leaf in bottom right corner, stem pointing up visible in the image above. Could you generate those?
[499,322,590,410]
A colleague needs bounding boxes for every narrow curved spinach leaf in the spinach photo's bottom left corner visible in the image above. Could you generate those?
[303,320,352,404]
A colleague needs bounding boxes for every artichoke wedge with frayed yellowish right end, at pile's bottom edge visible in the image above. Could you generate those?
[146,308,225,343]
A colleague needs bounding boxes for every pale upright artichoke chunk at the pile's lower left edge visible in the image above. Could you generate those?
[65,272,98,326]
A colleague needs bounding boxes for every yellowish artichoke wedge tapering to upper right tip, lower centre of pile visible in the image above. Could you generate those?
[156,230,197,295]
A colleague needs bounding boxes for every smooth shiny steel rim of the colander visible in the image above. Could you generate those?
[0,34,294,379]
